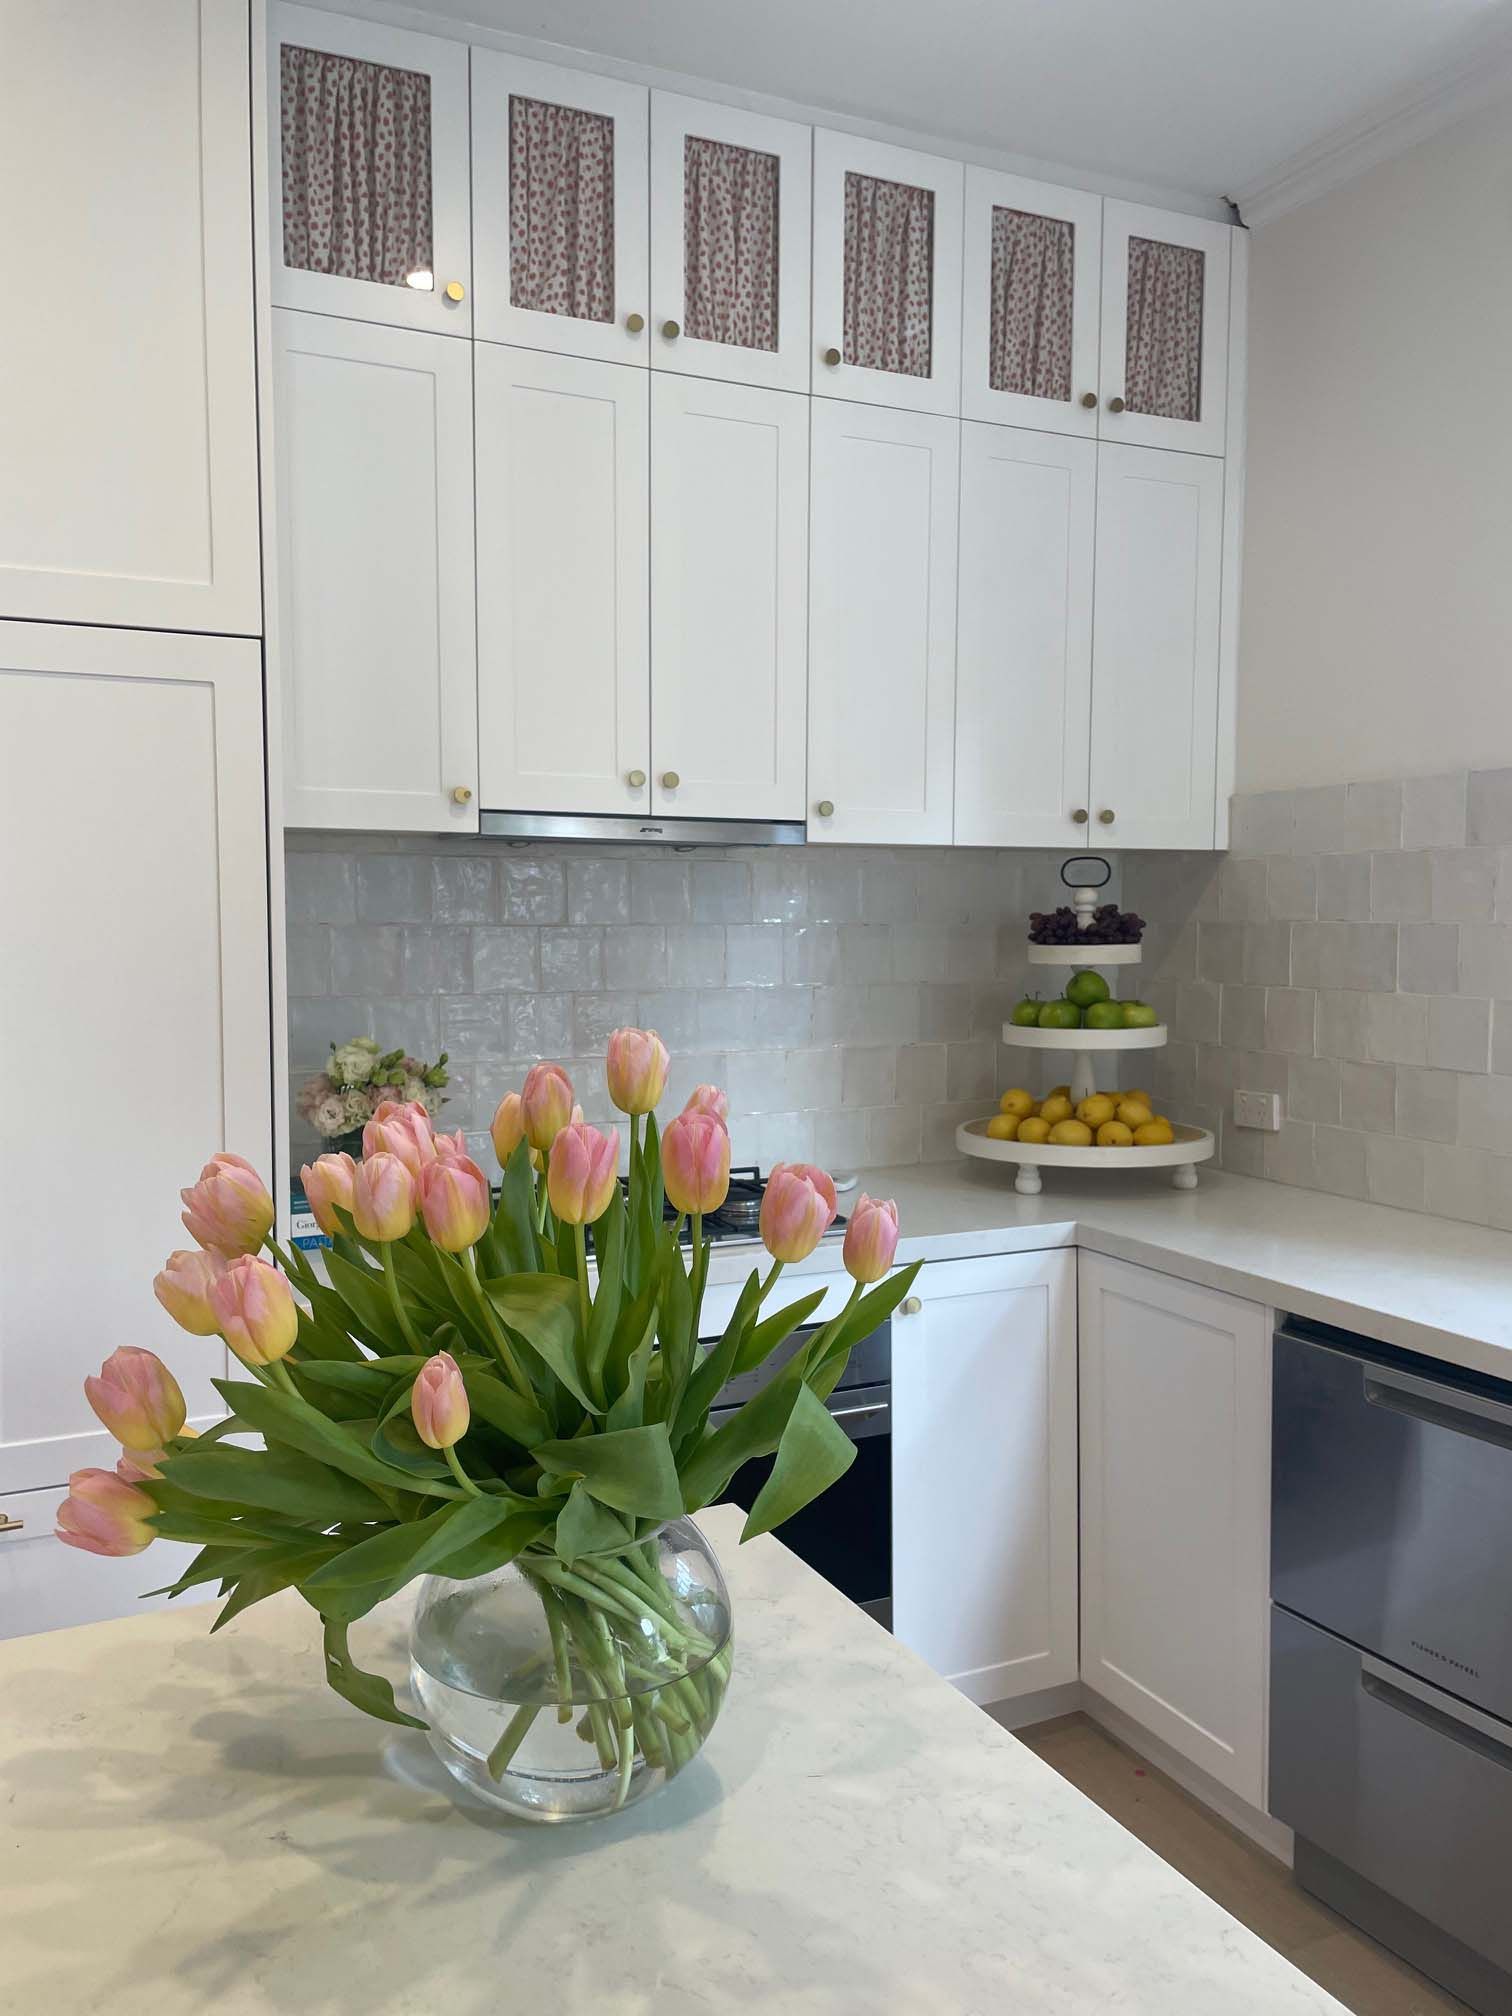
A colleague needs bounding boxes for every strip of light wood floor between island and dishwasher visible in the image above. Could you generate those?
[1016,1716,1468,2016]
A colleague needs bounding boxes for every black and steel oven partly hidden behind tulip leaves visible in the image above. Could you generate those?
[710,1320,893,1629]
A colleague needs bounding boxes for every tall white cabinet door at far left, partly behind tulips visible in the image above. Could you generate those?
[0,623,272,1516]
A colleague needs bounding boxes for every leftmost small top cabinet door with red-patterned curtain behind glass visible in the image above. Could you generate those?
[268,6,472,337]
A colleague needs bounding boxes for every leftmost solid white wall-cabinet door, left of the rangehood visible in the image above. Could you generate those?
[274,308,478,833]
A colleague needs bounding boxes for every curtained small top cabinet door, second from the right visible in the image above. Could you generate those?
[962,167,1103,439]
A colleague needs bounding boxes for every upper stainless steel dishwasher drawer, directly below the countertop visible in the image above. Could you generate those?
[1270,1327,1512,1722]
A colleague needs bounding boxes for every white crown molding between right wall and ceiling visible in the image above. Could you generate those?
[1234,28,1512,230]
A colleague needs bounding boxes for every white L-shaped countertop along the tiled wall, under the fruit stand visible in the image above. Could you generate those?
[710,1157,1512,1379]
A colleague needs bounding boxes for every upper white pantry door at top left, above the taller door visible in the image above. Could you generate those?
[0,0,262,635]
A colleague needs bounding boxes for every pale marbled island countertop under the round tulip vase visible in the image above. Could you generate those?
[0,1508,1341,2016]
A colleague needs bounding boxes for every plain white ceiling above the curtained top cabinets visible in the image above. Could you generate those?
[409,0,1512,198]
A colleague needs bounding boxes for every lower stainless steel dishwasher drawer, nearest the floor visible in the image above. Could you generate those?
[1270,1609,1512,2016]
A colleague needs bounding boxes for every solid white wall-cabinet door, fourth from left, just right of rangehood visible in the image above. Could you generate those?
[808,399,960,845]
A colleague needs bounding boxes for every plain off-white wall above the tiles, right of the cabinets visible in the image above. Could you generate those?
[1238,94,1512,790]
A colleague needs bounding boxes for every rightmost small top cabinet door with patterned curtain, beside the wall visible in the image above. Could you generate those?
[1099,202,1232,456]
